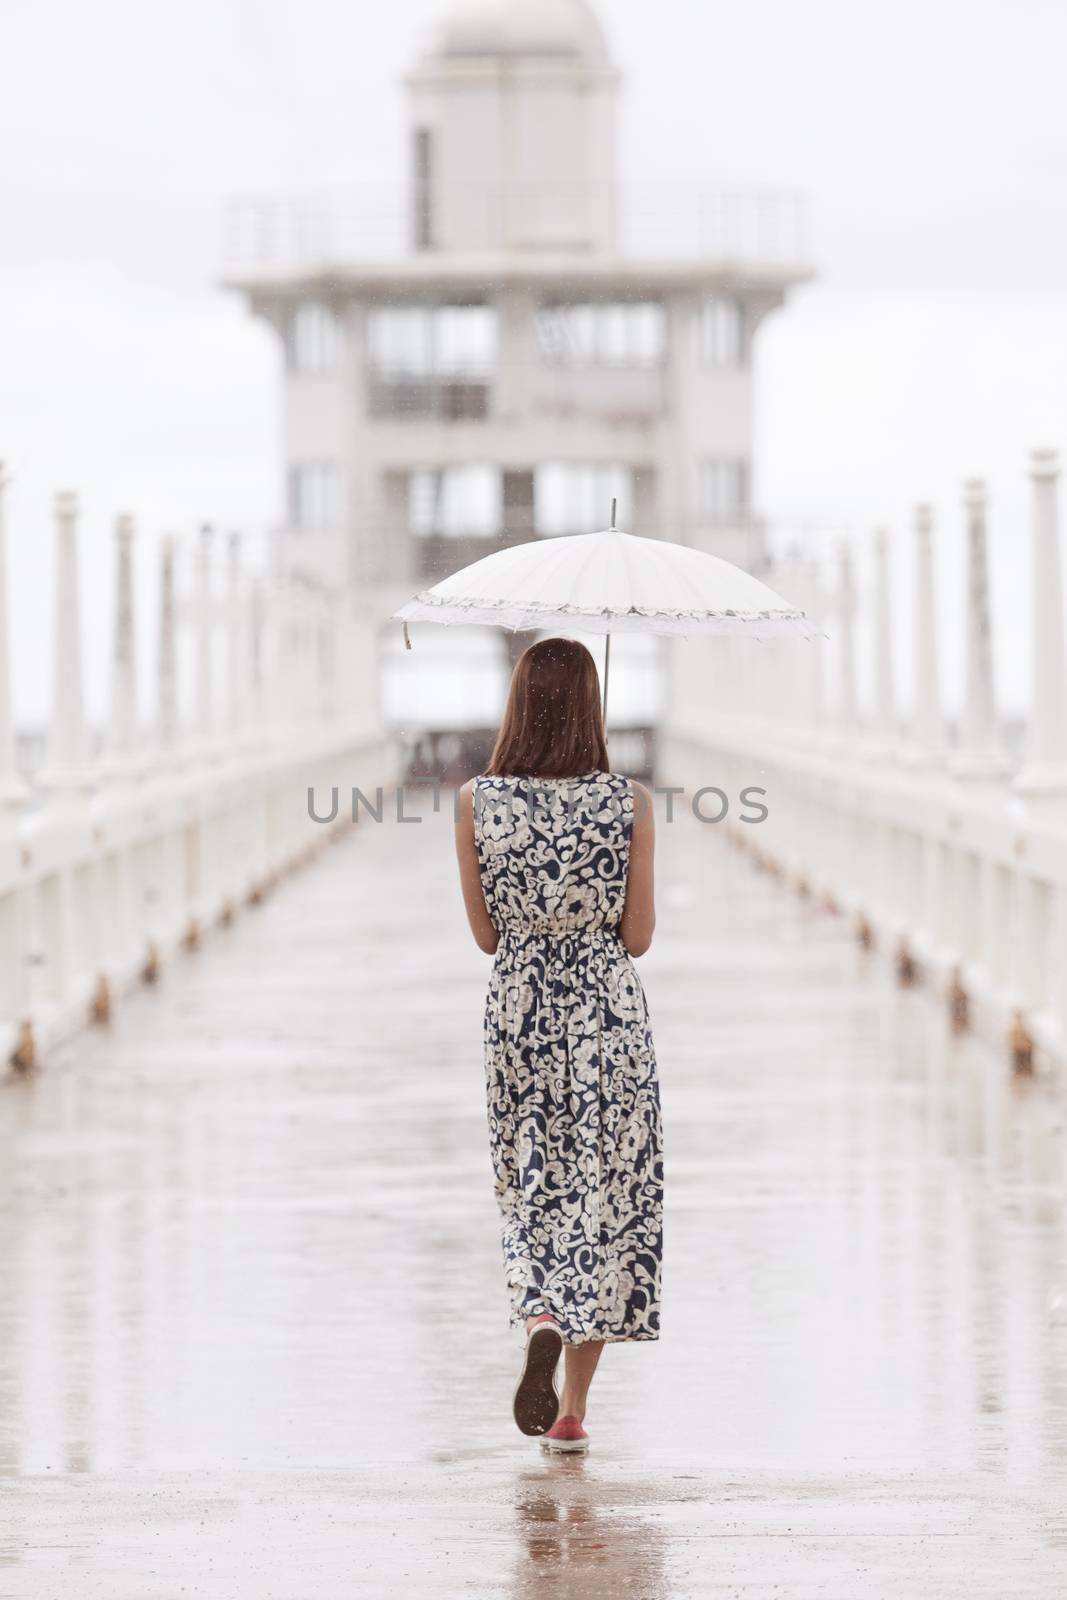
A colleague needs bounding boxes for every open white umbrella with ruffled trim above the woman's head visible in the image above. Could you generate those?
[394,506,819,715]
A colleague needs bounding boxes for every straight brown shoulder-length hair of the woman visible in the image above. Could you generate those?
[486,638,608,778]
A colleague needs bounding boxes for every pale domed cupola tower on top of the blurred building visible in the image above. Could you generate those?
[408,0,617,253]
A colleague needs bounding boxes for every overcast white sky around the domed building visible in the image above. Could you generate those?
[0,0,1067,715]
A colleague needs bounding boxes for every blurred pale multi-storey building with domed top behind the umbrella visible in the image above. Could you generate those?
[223,0,806,742]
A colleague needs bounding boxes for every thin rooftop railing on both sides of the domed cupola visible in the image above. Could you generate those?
[222,182,811,272]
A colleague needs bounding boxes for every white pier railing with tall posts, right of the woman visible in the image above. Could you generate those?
[662,451,1067,1070]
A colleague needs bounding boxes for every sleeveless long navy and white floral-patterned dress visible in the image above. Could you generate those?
[474,773,662,1344]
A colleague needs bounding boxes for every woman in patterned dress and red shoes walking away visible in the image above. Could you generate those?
[456,638,662,1451]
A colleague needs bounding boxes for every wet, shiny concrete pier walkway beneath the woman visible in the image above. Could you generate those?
[0,816,1067,1600]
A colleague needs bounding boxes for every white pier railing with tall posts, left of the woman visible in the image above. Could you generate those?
[0,474,394,1069]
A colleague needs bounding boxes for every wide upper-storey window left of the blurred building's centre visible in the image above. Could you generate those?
[366,306,496,382]
